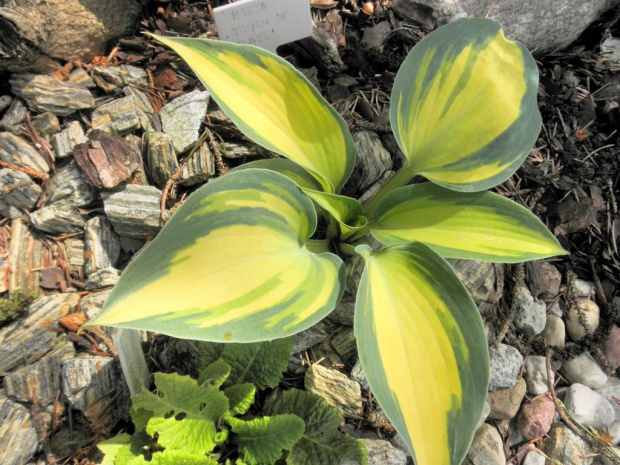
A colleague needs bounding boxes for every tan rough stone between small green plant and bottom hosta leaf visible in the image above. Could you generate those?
[304,365,362,415]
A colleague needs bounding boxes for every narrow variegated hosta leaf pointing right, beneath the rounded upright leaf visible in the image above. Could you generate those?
[370,183,566,263]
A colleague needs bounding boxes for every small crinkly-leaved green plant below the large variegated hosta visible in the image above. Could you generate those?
[98,339,368,465]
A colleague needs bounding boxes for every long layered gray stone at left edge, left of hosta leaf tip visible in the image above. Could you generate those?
[0,293,79,376]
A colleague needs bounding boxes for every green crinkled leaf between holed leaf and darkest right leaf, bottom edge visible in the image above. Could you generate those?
[229,414,305,465]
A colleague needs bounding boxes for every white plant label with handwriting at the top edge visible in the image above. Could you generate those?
[213,0,312,53]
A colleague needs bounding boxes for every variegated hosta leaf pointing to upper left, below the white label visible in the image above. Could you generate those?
[151,36,355,192]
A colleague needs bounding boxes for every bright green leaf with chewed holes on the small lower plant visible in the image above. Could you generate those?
[132,373,228,454]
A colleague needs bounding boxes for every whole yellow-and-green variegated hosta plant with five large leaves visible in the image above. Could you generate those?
[91,19,564,465]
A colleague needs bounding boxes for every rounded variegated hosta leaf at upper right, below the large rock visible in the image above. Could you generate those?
[390,18,541,192]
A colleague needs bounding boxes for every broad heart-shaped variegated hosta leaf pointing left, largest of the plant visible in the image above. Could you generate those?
[83,169,344,342]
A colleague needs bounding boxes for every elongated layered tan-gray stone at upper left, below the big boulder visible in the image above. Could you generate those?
[9,73,95,116]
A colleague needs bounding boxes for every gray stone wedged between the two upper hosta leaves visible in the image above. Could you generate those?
[347,130,393,192]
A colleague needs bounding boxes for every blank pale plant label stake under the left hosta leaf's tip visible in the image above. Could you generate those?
[114,329,151,396]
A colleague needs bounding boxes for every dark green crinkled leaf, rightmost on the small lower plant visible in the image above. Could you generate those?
[265,389,368,465]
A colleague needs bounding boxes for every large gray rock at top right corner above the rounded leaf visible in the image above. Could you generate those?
[393,0,618,54]
